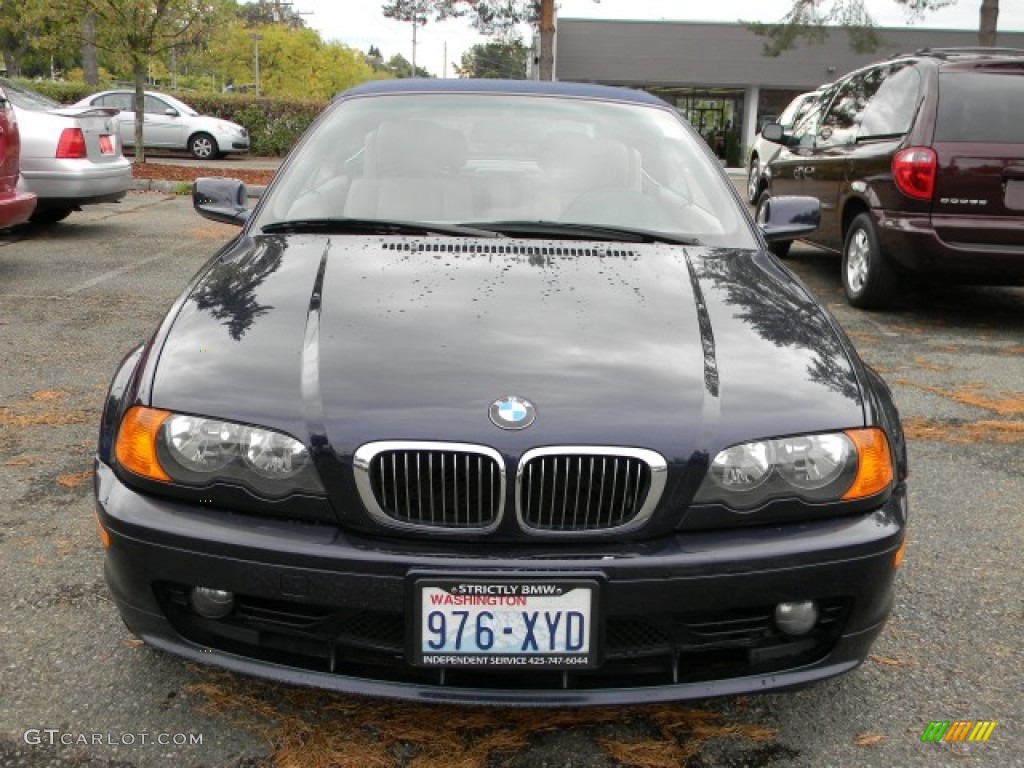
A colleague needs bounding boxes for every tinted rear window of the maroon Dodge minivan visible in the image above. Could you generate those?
[935,68,1024,143]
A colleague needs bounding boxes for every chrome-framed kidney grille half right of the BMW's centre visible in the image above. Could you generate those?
[516,446,666,534]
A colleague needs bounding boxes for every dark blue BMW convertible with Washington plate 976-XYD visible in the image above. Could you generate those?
[95,80,907,706]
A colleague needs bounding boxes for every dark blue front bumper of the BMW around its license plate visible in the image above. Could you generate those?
[96,463,906,707]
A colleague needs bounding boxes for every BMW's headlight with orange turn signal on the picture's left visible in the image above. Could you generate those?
[116,406,324,497]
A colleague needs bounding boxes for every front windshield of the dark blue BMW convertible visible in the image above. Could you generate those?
[255,93,756,248]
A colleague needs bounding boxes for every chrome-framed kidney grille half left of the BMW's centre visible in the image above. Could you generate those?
[354,441,505,531]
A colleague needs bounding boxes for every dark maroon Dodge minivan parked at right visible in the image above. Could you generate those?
[761,48,1024,308]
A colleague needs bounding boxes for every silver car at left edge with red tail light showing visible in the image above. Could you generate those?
[0,80,132,223]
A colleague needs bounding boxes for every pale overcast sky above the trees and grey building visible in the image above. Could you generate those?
[292,0,1024,77]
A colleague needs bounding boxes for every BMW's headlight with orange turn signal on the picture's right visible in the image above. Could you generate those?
[694,428,893,510]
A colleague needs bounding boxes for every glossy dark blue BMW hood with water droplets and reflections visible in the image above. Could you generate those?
[150,236,864,461]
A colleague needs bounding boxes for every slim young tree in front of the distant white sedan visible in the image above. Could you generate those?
[81,0,226,163]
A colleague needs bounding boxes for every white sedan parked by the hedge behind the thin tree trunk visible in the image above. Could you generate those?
[77,90,249,160]
